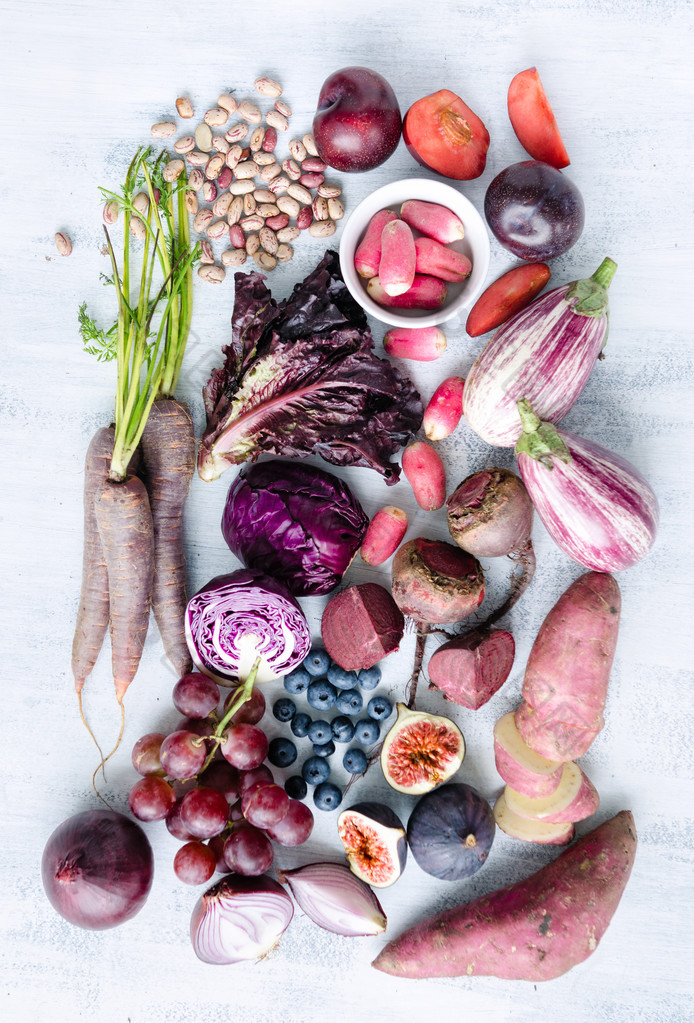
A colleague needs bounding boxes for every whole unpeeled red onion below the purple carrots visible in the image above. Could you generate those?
[41,809,154,931]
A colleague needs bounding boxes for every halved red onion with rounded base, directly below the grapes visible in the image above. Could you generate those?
[190,874,294,966]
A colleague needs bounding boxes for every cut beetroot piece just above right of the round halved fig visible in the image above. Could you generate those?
[427,629,516,710]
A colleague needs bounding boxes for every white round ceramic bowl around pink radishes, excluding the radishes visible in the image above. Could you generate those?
[340,178,489,326]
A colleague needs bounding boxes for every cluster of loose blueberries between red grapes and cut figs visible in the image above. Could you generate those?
[268,648,393,810]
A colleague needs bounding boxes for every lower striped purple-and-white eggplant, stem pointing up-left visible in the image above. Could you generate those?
[516,401,658,572]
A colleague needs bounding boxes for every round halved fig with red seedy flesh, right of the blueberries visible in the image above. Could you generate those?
[381,703,465,796]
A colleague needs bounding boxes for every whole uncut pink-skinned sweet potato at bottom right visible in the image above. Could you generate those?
[373,810,637,982]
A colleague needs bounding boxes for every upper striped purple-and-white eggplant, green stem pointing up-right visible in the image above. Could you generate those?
[463,258,617,447]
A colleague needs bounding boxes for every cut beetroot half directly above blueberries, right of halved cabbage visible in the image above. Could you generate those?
[320,582,404,671]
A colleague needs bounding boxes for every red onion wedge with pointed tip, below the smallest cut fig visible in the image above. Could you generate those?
[277,863,386,938]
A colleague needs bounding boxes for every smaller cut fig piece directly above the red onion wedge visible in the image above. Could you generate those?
[338,803,407,888]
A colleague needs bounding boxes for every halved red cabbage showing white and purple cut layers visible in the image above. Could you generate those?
[185,569,311,685]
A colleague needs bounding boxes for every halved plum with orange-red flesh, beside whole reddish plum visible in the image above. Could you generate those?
[402,89,489,181]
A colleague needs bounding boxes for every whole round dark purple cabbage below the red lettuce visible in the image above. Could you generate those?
[222,458,368,596]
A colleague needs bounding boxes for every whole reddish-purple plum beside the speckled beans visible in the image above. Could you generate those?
[313,68,402,171]
